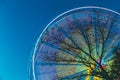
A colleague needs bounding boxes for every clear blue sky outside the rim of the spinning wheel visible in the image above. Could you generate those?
[0,0,120,80]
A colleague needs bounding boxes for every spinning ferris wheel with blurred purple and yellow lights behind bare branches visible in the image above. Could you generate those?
[30,6,120,80]
